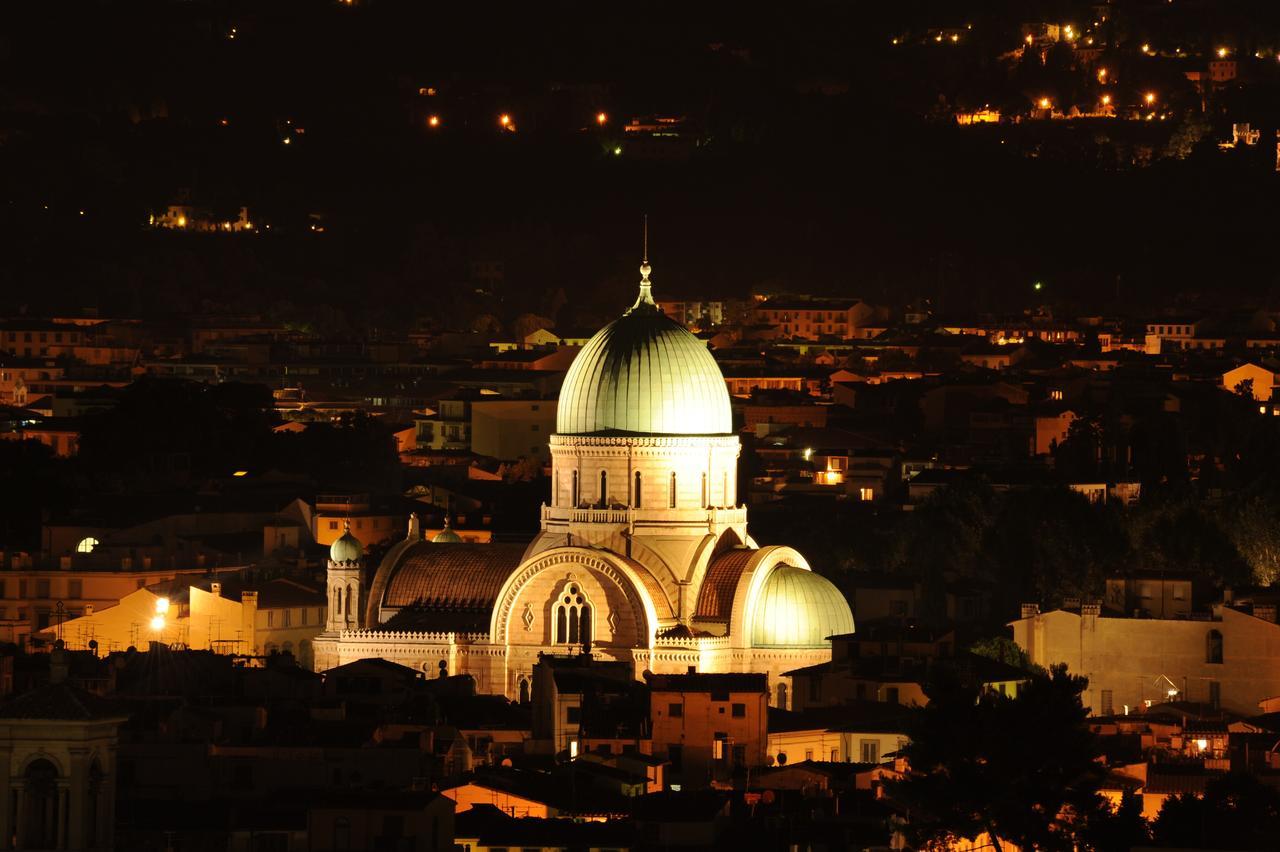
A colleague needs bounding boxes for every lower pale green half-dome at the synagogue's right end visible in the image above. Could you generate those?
[751,565,854,647]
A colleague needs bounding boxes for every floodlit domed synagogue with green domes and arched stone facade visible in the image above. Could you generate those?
[315,252,854,706]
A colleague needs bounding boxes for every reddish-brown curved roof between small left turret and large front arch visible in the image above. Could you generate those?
[381,541,525,611]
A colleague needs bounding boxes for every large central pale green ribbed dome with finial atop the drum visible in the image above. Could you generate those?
[556,264,733,435]
